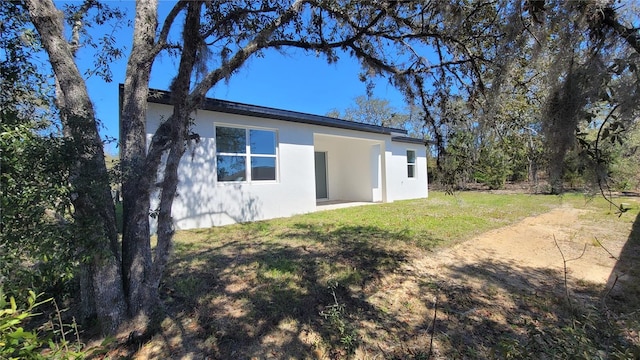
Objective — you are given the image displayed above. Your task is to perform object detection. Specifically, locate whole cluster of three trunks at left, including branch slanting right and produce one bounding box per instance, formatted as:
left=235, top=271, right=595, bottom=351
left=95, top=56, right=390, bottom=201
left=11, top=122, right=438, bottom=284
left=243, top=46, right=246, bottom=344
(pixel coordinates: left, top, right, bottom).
left=28, top=0, right=303, bottom=328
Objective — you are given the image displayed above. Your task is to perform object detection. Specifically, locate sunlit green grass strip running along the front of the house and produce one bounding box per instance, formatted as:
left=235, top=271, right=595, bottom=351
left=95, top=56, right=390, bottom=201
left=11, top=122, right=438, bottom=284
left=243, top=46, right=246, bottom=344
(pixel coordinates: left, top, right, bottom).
left=176, top=192, right=606, bottom=249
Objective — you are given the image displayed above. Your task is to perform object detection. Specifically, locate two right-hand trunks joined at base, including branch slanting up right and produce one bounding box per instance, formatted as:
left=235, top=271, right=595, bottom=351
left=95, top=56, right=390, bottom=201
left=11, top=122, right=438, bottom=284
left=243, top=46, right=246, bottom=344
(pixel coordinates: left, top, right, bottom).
left=121, top=0, right=302, bottom=315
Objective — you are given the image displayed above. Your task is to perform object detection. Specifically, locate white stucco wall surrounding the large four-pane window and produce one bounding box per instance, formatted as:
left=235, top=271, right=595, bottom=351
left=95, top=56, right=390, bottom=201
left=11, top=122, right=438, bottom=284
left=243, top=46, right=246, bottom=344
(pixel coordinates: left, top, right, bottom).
left=147, top=104, right=316, bottom=229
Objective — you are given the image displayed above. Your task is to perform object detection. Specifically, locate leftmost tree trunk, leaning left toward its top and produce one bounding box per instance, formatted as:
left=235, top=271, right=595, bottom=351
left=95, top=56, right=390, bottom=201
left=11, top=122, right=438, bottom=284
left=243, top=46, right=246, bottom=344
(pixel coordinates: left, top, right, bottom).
left=24, top=0, right=126, bottom=333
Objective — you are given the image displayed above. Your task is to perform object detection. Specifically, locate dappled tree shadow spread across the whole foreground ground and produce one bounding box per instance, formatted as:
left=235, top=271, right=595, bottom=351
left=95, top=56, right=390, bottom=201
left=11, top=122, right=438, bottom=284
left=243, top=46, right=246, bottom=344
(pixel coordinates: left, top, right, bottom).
left=138, top=221, right=638, bottom=359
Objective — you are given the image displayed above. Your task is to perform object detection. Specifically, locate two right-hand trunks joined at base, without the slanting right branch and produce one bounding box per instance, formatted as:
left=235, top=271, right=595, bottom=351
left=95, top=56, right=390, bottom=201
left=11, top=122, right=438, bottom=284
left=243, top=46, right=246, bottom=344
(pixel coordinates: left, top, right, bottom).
left=120, top=0, right=201, bottom=316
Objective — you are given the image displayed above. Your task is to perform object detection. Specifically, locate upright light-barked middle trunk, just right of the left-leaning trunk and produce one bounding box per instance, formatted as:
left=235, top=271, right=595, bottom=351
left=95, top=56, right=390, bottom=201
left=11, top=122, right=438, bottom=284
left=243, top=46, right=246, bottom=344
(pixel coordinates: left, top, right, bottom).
left=120, top=0, right=160, bottom=316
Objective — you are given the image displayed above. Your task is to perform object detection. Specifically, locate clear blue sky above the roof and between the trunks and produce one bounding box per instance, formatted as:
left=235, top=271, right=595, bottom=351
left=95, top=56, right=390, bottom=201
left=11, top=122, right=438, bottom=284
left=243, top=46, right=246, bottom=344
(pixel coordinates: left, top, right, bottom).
left=78, top=1, right=405, bottom=153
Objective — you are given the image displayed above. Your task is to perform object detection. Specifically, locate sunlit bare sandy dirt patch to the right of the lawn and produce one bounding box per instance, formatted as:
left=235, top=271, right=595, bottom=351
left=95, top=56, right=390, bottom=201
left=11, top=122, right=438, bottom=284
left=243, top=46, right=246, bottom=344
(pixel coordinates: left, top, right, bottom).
left=428, top=207, right=625, bottom=284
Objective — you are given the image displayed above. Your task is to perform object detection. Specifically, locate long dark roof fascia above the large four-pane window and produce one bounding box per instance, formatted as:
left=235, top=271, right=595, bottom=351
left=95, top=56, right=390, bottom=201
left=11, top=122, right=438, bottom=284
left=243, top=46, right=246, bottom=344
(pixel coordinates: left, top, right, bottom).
left=148, top=89, right=407, bottom=135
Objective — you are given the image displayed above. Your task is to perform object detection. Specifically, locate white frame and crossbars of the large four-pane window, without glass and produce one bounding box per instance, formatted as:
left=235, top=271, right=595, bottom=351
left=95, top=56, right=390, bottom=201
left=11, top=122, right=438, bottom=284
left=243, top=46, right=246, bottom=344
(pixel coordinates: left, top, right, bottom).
left=213, top=123, right=280, bottom=185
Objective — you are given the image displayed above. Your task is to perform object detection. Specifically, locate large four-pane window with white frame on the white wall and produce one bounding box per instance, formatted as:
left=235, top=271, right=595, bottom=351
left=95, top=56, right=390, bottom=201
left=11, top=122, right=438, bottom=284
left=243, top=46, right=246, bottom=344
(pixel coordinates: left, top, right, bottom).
left=216, top=126, right=277, bottom=182
